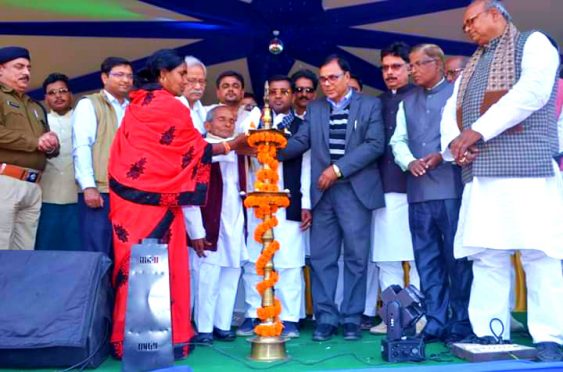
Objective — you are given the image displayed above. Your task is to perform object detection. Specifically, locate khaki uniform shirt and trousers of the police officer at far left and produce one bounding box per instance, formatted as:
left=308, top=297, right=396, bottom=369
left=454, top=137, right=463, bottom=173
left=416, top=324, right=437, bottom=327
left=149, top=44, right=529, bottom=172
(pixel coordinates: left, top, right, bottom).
left=0, top=84, right=49, bottom=249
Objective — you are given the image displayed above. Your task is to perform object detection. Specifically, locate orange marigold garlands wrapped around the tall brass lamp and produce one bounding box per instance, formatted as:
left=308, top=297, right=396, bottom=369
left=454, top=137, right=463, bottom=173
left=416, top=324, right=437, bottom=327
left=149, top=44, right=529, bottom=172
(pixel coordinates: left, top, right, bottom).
left=248, top=131, right=289, bottom=337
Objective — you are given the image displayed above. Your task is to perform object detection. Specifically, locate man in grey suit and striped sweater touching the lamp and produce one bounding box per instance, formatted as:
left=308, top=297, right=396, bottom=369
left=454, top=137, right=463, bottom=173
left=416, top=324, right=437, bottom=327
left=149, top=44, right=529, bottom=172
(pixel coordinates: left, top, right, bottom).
left=279, top=55, right=385, bottom=341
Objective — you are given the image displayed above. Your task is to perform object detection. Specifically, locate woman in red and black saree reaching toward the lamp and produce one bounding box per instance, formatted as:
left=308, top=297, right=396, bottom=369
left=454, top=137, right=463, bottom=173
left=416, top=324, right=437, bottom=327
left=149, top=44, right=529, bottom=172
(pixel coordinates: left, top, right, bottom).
left=109, top=49, right=245, bottom=358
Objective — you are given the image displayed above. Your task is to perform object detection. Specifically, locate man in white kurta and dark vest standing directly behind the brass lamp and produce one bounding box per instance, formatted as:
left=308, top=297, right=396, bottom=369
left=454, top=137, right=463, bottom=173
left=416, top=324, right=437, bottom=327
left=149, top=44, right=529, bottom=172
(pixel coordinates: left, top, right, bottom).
left=238, top=77, right=311, bottom=337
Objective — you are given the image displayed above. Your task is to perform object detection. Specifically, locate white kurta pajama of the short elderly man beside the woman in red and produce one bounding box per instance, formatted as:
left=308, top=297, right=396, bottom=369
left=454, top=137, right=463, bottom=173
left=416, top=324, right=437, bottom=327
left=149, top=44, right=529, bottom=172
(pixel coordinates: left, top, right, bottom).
left=183, top=139, right=248, bottom=333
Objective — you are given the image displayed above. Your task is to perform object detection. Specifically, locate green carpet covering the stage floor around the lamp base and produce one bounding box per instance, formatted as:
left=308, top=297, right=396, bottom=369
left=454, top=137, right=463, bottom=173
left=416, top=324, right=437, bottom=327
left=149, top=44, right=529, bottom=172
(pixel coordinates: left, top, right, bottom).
left=2, top=313, right=532, bottom=372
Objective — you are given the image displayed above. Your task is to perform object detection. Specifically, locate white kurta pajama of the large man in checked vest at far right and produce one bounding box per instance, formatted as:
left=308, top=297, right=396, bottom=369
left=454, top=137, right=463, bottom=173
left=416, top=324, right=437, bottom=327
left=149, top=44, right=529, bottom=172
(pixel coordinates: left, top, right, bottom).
left=442, top=32, right=563, bottom=344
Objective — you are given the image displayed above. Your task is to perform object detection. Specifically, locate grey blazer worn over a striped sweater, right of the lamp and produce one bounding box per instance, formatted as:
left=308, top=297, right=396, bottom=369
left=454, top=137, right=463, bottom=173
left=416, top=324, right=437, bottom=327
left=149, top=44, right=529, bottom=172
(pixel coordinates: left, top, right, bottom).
left=278, top=92, right=385, bottom=209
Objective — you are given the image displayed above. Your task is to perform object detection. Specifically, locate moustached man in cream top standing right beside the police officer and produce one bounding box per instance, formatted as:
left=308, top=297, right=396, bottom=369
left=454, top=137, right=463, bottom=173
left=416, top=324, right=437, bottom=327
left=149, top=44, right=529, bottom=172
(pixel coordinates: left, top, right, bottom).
left=35, top=73, right=80, bottom=251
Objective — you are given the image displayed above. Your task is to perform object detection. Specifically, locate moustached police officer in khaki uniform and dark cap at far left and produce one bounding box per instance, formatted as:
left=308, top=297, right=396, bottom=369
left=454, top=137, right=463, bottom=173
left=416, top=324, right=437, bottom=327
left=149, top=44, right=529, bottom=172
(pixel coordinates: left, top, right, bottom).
left=0, top=46, right=59, bottom=250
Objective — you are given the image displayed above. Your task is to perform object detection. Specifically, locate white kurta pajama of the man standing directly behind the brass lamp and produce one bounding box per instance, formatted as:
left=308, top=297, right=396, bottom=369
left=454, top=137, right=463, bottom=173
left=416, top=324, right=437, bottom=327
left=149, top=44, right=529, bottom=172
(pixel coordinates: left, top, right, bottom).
left=243, top=114, right=311, bottom=322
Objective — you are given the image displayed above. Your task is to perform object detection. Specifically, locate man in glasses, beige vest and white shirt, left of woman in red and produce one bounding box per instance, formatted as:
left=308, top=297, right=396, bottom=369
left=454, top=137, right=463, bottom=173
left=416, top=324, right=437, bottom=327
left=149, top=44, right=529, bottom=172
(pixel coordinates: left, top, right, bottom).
left=72, top=57, right=133, bottom=257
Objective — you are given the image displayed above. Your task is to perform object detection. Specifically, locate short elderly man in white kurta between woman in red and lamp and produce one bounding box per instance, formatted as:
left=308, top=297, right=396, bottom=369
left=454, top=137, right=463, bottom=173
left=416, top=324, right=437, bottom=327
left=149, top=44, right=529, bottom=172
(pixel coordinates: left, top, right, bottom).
left=184, top=106, right=248, bottom=343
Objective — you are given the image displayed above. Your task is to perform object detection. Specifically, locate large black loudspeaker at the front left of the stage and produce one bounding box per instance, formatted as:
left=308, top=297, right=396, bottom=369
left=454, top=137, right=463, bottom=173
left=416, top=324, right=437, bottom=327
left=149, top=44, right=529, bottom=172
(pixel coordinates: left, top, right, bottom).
left=0, top=251, right=113, bottom=368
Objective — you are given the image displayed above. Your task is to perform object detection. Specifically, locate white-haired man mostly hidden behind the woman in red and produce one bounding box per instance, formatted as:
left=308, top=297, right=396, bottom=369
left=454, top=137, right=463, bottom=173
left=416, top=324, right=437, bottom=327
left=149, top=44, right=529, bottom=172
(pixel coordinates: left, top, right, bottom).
left=178, top=56, right=207, bottom=134
